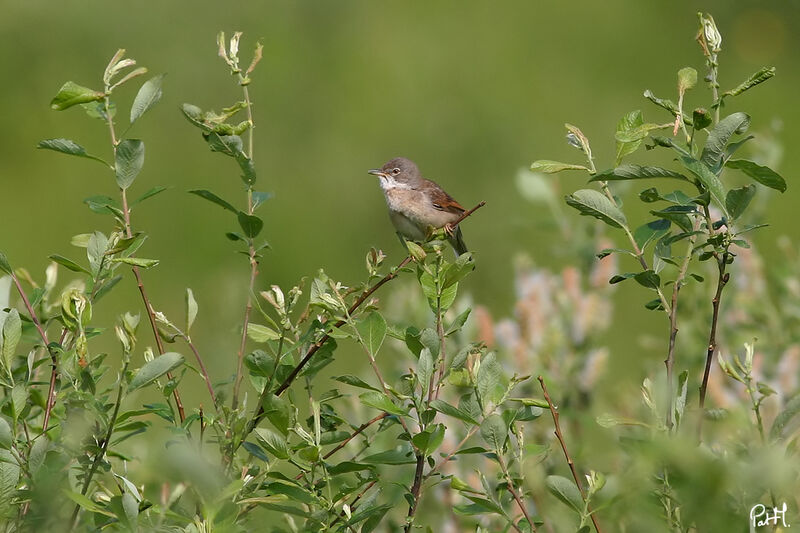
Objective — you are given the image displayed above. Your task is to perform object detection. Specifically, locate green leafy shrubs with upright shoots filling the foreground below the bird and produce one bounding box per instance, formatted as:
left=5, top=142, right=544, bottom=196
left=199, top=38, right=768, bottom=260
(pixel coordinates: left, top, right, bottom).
left=0, top=15, right=800, bottom=533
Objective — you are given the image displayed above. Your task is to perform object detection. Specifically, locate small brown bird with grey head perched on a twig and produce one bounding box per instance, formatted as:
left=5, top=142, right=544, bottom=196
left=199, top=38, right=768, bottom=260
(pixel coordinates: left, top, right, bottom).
left=368, top=157, right=467, bottom=256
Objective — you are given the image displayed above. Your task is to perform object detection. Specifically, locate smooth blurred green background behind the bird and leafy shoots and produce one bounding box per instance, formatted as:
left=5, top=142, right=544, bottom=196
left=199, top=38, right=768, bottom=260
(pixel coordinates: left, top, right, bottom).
left=0, top=0, right=800, bottom=404
